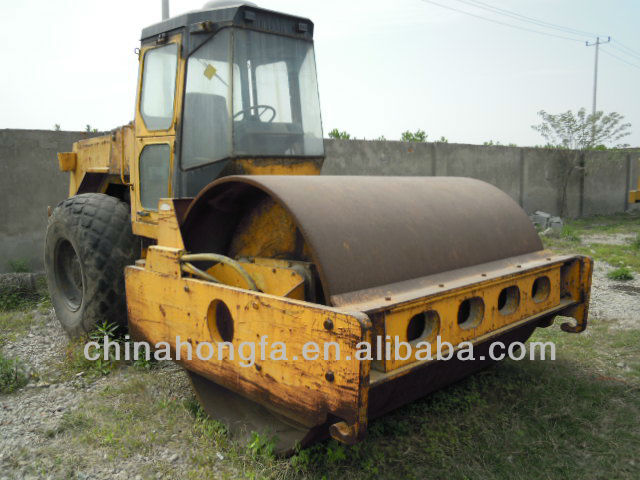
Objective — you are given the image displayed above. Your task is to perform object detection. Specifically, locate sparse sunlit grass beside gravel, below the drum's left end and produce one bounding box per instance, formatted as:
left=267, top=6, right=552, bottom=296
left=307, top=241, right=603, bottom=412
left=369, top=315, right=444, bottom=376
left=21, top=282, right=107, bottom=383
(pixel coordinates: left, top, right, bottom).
left=31, top=366, right=238, bottom=478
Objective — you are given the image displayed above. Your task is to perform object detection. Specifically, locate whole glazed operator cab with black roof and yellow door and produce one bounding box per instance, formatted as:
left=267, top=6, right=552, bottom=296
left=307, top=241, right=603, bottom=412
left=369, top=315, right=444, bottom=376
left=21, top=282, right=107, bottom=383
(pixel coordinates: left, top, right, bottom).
left=134, top=1, right=324, bottom=217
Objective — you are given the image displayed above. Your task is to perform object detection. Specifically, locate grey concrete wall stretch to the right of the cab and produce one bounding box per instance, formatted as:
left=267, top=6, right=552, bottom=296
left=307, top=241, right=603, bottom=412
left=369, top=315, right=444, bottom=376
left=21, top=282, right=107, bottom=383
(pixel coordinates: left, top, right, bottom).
left=322, top=140, right=640, bottom=217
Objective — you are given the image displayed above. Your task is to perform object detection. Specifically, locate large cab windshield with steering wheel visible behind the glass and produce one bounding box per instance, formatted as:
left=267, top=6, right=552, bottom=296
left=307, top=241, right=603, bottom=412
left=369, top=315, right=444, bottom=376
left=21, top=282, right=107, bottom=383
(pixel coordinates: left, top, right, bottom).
left=181, top=28, right=324, bottom=169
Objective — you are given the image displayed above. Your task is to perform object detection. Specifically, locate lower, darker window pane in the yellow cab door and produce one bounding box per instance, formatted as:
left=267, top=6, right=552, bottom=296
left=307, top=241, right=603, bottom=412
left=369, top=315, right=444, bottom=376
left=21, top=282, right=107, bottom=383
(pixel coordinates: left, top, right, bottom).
left=140, top=143, right=171, bottom=210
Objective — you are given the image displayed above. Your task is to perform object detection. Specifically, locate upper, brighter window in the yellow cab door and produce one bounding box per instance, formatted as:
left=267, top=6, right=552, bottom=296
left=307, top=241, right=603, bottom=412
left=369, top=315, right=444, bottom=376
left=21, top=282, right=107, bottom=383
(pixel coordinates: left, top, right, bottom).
left=140, top=43, right=178, bottom=130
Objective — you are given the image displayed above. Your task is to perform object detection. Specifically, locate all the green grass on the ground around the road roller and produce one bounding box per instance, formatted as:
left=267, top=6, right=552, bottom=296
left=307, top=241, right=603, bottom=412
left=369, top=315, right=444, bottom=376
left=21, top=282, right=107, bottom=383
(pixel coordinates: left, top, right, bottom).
left=0, top=216, right=640, bottom=480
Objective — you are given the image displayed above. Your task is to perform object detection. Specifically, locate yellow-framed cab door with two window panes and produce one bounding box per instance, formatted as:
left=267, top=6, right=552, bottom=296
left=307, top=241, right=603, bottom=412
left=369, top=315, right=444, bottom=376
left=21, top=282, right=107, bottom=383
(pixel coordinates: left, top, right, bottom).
left=130, top=35, right=184, bottom=238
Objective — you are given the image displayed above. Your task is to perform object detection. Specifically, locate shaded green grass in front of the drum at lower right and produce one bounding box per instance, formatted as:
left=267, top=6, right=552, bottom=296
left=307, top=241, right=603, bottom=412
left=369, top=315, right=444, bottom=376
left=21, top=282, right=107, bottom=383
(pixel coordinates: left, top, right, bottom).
left=276, top=323, right=640, bottom=479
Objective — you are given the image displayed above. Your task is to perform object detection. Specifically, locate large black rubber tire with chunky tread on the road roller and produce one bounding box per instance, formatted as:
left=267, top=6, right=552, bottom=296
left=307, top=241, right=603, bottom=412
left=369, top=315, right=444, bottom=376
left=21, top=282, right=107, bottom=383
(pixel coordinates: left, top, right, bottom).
left=44, top=193, right=139, bottom=337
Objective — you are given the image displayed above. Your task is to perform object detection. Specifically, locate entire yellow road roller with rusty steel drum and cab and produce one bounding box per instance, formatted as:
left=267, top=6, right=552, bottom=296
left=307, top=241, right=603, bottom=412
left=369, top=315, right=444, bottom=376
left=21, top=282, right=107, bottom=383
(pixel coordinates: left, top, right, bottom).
left=45, top=2, right=592, bottom=454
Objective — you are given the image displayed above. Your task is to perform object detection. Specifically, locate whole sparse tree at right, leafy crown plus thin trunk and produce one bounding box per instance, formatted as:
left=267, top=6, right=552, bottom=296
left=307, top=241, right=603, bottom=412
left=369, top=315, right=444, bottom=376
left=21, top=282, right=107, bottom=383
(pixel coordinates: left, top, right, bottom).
left=531, top=108, right=631, bottom=216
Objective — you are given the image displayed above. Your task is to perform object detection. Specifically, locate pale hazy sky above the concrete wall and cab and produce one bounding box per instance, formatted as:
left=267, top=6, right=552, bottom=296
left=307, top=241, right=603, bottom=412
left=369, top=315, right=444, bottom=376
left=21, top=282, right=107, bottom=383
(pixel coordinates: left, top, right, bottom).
left=0, top=0, right=640, bottom=146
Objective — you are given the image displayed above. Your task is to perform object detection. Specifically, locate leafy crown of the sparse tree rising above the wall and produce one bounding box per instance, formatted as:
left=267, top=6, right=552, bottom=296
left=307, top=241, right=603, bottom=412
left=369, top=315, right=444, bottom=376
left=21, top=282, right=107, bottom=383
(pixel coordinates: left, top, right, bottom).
left=531, top=108, right=631, bottom=150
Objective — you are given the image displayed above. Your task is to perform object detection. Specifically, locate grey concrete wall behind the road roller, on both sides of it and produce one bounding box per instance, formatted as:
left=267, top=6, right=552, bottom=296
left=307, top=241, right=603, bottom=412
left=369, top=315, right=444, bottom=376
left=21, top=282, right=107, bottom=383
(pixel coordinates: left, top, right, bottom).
left=0, top=130, right=640, bottom=272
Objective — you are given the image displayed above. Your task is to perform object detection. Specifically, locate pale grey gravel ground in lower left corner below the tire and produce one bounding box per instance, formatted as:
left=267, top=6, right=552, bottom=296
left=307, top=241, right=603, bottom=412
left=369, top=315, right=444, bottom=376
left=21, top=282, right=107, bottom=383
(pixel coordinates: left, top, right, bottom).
left=0, top=310, right=189, bottom=480
